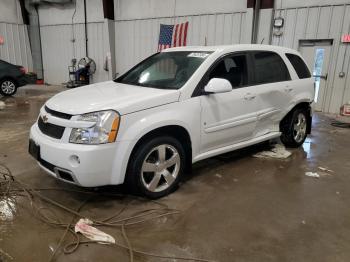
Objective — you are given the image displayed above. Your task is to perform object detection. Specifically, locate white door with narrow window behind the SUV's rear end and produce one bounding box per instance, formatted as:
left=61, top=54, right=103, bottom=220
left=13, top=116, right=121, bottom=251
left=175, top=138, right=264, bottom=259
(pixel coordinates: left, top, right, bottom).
left=299, top=39, right=333, bottom=111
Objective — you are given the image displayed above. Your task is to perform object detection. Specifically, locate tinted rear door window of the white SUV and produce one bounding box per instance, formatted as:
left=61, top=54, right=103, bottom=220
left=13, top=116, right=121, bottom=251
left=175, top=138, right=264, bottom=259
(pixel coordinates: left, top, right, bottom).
left=253, top=52, right=290, bottom=84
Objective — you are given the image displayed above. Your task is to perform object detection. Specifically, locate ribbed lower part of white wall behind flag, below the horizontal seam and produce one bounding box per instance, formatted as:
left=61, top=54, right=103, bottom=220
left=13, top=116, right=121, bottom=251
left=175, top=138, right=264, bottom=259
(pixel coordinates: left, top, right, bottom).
left=115, top=12, right=251, bottom=74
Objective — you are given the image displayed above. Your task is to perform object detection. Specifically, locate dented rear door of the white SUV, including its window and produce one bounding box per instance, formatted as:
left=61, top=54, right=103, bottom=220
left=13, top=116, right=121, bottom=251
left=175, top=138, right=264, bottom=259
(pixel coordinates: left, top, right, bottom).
left=251, top=51, right=295, bottom=137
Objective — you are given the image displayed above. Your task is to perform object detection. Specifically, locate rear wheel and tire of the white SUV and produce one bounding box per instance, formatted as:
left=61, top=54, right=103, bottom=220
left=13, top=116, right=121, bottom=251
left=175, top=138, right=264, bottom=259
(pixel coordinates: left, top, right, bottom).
left=281, top=108, right=309, bottom=148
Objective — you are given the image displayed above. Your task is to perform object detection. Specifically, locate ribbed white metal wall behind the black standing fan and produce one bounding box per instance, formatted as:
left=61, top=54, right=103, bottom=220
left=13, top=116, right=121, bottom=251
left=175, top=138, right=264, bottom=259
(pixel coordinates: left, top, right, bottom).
left=40, top=22, right=109, bottom=84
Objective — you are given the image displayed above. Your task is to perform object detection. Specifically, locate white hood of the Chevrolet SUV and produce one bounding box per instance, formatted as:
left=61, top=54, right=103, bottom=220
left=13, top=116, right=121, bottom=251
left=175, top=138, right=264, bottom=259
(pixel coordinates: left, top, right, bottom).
left=46, top=81, right=180, bottom=115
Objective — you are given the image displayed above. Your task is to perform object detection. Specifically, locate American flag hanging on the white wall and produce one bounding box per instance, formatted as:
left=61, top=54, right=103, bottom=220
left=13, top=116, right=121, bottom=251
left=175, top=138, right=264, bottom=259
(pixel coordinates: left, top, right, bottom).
left=158, top=22, right=188, bottom=52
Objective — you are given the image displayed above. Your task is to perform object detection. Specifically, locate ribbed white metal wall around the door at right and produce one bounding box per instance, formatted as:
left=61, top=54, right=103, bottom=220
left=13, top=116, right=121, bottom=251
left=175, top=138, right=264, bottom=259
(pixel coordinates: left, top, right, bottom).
left=272, top=4, right=350, bottom=113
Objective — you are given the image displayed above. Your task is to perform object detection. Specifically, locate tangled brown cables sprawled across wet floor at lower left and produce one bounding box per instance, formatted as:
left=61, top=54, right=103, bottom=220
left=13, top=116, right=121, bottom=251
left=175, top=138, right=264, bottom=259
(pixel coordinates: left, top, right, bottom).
left=0, top=164, right=213, bottom=262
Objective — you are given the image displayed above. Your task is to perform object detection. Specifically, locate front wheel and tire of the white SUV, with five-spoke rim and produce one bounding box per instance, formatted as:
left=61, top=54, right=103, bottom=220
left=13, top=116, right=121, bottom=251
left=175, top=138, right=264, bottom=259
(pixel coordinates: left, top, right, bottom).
left=126, top=136, right=186, bottom=199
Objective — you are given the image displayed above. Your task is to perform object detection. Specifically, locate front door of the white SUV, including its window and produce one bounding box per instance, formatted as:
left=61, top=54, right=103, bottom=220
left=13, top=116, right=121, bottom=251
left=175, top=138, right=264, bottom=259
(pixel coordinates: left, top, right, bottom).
left=200, top=53, right=257, bottom=152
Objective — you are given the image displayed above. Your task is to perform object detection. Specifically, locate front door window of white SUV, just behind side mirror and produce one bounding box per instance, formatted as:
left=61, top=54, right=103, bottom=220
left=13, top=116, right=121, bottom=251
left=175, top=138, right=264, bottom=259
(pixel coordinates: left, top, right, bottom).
left=209, top=55, right=248, bottom=88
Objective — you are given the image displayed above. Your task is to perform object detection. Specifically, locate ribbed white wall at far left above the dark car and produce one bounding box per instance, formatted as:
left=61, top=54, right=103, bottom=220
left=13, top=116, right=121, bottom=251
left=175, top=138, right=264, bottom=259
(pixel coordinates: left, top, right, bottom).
left=0, top=22, right=33, bottom=71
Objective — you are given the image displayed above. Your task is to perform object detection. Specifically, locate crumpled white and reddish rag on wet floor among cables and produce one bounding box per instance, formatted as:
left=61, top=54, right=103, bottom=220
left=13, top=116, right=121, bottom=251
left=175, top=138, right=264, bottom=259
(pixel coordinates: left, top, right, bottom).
left=74, top=218, right=115, bottom=244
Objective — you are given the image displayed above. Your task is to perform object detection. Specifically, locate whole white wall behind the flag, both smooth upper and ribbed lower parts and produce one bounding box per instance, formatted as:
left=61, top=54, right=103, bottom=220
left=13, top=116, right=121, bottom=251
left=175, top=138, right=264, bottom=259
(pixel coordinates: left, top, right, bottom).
left=114, top=0, right=253, bottom=74
